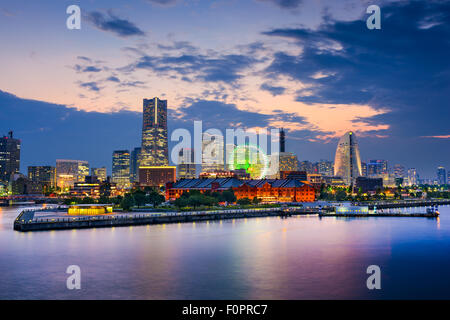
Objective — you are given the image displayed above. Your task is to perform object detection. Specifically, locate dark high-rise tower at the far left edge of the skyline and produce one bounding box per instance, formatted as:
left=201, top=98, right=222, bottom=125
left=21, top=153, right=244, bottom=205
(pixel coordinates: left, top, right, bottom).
left=0, top=131, right=20, bottom=184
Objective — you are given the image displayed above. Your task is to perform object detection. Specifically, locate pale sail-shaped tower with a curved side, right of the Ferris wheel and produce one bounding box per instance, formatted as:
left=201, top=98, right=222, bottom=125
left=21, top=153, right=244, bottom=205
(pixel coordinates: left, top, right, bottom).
left=334, top=131, right=362, bottom=185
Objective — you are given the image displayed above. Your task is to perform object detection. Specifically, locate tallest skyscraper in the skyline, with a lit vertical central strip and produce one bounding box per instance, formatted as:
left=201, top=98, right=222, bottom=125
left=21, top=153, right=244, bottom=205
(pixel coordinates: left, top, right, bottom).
left=139, top=97, right=169, bottom=166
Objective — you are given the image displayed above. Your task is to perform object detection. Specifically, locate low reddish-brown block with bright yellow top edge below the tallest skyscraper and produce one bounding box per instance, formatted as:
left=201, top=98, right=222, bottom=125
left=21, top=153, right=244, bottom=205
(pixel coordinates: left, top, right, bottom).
left=139, top=166, right=177, bottom=188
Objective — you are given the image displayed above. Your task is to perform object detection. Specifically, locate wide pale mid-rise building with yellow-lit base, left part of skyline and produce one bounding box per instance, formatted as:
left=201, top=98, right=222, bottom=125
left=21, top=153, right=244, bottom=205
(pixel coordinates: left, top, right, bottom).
left=56, top=159, right=89, bottom=189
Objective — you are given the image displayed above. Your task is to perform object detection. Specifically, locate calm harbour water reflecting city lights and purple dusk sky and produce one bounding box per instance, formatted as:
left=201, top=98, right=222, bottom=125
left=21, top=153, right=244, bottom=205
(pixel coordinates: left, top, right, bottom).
left=0, top=207, right=450, bottom=299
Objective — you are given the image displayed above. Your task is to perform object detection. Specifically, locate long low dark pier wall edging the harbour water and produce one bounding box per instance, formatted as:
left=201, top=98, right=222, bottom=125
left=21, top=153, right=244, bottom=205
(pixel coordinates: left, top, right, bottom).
left=14, top=207, right=319, bottom=232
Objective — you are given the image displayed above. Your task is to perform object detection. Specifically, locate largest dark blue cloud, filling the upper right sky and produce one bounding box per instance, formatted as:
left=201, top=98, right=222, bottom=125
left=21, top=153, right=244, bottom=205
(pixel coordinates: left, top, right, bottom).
left=264, top=1, right=450, bottom=138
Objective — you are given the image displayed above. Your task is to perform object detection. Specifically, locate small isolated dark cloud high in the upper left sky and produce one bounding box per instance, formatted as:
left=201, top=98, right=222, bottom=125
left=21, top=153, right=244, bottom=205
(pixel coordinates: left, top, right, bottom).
left=87, top=11, right=145, bottom=37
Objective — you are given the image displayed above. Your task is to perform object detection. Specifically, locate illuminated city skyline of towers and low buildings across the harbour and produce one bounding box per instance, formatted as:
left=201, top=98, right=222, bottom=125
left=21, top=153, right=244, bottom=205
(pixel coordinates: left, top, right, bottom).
left=0, top=97, right=450, bottom=201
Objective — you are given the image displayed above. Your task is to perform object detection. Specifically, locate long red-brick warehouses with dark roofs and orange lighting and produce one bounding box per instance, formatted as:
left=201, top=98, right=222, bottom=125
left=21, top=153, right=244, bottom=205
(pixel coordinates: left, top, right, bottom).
left=166, top=178, right=315, bottom=202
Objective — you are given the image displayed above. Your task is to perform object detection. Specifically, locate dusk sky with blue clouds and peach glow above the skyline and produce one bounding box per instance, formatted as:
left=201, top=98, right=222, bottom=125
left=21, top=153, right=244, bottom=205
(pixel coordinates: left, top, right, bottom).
left=0, top=0, right=450, bottom=177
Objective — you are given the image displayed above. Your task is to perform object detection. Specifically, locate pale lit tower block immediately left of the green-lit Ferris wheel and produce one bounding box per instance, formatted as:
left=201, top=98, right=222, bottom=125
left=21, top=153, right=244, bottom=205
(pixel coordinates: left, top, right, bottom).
left=202, top=132, right=225, bottom=172
